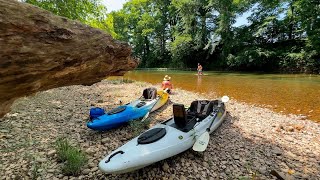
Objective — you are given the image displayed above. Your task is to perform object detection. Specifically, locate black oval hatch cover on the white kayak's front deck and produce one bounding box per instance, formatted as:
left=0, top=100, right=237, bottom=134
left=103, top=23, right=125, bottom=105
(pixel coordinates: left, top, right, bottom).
left=138, top=128, right=167, bottom=144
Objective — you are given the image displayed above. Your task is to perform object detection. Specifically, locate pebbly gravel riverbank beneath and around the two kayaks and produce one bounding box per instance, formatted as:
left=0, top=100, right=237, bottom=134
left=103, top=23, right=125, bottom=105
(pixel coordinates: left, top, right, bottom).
left=0, top=80, right=320, bottom=179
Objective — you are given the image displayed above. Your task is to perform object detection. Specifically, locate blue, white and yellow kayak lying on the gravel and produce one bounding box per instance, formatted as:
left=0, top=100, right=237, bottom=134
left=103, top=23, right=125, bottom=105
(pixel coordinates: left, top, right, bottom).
left=87, top=88, right=169, bottom=131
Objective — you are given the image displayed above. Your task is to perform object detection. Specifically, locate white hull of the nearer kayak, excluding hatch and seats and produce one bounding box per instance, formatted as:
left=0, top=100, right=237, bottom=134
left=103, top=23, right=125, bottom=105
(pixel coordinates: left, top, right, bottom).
left=99, top=100, right=226, bottom=174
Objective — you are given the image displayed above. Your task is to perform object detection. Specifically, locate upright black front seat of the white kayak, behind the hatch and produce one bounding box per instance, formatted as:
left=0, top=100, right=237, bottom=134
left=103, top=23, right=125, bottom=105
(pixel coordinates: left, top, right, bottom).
left=173, top=104, right=197, bottom=132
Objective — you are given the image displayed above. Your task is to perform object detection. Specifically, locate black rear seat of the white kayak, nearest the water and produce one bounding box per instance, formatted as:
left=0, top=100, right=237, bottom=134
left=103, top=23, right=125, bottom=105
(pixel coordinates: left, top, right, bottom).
left=187, top=100, right=215, bottom=121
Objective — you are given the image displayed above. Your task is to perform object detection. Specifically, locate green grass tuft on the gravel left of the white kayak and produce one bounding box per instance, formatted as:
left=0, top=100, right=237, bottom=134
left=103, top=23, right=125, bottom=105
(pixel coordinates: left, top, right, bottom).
left=56, top=138, right=87, bottom=175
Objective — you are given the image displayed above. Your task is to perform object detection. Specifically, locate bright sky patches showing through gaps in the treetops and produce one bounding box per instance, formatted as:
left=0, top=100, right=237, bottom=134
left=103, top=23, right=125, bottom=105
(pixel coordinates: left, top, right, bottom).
left=102, top=0, right=252, bottom=27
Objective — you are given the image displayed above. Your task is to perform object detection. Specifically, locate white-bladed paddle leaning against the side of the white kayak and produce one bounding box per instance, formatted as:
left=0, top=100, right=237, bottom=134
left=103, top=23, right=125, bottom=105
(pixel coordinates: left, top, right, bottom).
left=192, top=96, right=229, bottom=152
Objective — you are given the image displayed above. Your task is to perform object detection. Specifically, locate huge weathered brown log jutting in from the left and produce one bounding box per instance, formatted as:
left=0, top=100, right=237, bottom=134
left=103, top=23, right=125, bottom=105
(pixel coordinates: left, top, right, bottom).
left=0, top=0, right=138, bottom=117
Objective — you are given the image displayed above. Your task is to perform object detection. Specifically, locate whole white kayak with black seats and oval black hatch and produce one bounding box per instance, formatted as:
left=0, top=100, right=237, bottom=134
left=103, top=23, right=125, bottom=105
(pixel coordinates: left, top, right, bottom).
left=99, top=100, right=226, bottom=174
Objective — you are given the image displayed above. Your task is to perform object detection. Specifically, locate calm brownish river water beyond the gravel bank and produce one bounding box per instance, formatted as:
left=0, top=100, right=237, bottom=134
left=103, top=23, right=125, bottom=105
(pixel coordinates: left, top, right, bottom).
left=117, top=70, right=320, bottom=122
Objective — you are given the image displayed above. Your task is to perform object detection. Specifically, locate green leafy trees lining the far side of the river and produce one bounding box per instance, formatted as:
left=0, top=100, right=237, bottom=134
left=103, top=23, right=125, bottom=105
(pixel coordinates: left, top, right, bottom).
left=25, top=0, right=320, bottom=73
